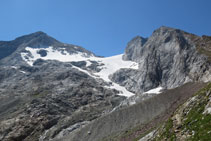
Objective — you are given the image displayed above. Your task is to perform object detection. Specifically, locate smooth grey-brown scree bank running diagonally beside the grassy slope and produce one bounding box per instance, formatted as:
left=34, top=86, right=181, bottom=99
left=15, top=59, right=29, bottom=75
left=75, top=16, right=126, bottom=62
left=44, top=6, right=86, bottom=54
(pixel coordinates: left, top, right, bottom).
left=59, top=83, right=204, bottom=141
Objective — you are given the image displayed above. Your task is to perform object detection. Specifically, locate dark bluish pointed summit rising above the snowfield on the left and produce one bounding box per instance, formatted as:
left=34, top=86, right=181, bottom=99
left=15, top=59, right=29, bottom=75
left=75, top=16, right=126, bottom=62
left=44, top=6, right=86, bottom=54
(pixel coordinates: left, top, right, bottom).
left=0, top=32, right=94, bottom=65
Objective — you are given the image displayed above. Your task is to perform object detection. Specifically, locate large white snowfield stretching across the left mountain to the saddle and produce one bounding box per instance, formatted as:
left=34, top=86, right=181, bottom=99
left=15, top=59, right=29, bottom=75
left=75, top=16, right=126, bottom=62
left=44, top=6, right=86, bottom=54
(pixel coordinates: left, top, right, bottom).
left=21, top=46, right=138, bottom=97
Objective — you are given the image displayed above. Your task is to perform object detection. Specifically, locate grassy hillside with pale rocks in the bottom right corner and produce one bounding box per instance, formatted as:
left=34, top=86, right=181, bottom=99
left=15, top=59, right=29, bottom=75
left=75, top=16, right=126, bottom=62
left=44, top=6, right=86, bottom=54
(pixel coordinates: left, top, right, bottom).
left=151, top=84, right=211, bottom=141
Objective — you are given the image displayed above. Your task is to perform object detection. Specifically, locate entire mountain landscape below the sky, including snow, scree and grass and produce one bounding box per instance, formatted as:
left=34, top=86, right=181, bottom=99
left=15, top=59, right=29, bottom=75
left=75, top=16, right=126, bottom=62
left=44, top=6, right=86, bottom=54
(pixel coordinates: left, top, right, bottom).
left=0, top=26, right=211, bottom=141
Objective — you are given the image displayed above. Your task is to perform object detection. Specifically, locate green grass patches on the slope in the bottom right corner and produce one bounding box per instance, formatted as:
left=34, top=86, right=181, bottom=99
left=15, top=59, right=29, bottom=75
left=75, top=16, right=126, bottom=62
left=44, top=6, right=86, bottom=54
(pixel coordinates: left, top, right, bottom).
left=155, top=83, right=211, bottom=141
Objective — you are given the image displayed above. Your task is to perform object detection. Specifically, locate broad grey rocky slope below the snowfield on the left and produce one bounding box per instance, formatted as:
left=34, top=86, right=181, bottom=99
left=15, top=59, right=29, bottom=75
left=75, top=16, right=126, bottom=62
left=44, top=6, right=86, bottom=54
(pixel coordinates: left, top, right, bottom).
left=0, top=61, right=125, bottom=141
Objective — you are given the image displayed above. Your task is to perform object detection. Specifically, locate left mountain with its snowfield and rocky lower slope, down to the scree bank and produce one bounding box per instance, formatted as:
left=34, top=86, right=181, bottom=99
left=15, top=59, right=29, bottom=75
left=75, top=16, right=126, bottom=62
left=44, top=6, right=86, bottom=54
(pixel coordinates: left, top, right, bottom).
left=0, top=32, right=137, bottom=140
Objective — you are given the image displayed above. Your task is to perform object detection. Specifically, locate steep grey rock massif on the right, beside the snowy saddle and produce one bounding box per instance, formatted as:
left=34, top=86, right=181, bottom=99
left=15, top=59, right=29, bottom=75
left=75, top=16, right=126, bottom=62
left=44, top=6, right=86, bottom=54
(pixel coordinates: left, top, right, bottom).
left=111, top=27, right=211, bottom=93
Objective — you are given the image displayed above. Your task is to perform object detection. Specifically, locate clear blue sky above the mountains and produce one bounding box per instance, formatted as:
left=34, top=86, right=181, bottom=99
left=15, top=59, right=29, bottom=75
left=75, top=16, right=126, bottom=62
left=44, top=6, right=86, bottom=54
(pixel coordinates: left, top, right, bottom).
left=0, top=0, right=211, bottom=56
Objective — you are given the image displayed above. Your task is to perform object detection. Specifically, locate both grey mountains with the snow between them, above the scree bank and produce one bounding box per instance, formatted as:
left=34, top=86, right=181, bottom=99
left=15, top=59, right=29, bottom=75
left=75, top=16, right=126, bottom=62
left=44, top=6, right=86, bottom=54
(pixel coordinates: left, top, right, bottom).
left=0, top=27, right=211, bottom=141
